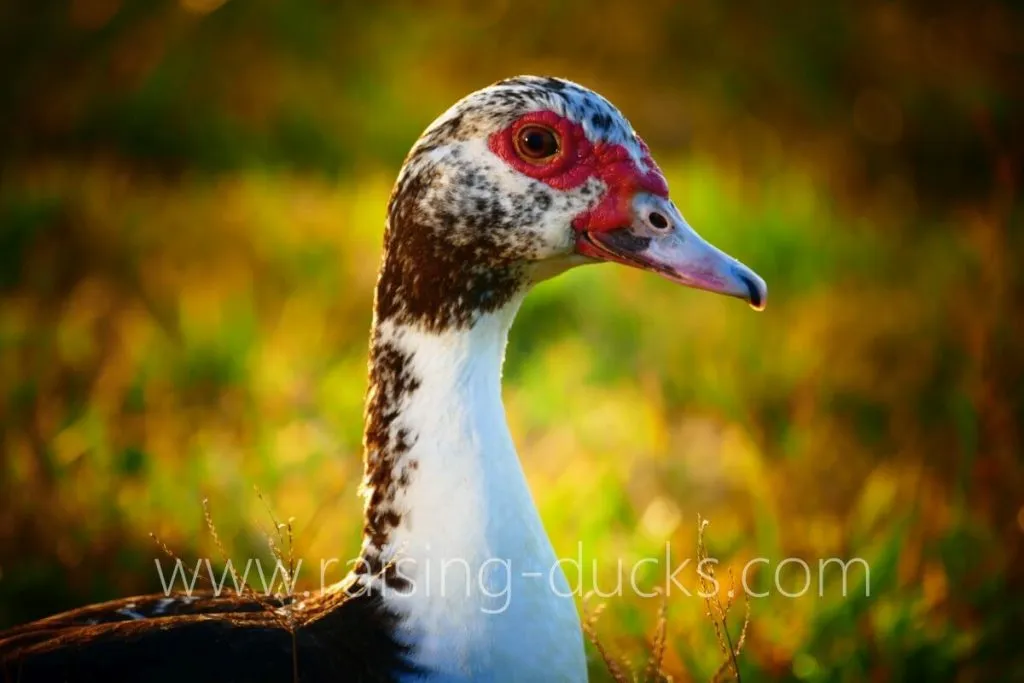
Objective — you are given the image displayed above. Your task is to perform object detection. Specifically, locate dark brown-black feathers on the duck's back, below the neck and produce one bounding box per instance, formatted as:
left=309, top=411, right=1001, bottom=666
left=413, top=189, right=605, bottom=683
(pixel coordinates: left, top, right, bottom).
left=0, top=593, right=412, bottom=683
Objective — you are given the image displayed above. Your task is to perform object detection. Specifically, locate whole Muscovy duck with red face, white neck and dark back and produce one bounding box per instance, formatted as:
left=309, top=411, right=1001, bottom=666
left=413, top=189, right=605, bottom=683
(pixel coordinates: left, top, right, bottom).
left=0, top=77, right=766, bottom=683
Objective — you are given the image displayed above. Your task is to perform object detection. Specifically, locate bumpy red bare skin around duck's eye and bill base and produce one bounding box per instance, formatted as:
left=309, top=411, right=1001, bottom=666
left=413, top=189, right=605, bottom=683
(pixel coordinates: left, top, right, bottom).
left=487, top=112, right=669, bottom=232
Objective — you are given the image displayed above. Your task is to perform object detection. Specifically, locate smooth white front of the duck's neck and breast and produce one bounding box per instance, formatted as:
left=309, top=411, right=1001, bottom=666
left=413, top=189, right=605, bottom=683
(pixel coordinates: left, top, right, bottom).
left=360, top=305, right=587, bottom=681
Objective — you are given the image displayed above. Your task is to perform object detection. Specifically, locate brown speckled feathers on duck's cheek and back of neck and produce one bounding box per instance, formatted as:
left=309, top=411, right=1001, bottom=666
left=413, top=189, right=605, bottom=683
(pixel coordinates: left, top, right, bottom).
left=357, top=125, right=552, bottom=583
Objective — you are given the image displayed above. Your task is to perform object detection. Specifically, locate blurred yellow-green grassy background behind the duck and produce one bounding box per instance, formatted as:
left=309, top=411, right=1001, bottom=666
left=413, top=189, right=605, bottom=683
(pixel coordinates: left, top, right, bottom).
left=0, top=0, right=1024, bottom=681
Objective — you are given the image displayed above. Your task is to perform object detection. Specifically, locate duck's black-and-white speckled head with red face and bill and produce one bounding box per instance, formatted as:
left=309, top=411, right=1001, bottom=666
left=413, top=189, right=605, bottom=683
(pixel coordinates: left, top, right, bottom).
left=377, top=76, right=767, bottom=330
